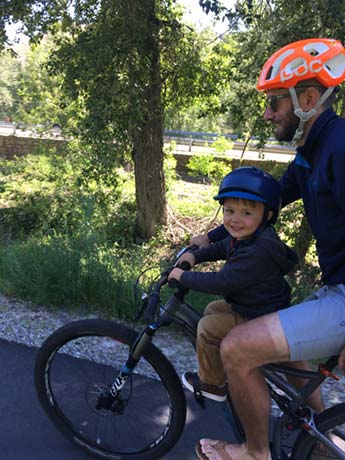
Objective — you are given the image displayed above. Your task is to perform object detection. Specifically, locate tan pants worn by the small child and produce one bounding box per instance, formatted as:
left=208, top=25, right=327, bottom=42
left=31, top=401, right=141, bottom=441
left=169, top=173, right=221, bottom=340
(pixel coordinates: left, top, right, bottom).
left=197, top=300, right=247, bottom=385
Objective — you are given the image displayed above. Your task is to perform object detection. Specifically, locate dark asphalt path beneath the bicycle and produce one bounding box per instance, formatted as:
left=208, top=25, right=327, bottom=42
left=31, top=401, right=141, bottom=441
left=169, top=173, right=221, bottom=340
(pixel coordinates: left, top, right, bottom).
left=0, top=339, right=234, bottom=460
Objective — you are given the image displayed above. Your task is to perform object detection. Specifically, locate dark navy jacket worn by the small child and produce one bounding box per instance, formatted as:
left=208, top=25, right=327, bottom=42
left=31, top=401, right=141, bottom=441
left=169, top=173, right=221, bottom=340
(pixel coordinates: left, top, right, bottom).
left=180, top=226, right=297, bottom=318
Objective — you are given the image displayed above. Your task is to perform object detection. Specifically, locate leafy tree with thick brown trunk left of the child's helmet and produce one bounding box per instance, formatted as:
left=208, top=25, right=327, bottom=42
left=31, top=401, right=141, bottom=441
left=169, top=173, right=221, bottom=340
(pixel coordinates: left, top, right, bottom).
left=0, top=0, right=226, bottom=237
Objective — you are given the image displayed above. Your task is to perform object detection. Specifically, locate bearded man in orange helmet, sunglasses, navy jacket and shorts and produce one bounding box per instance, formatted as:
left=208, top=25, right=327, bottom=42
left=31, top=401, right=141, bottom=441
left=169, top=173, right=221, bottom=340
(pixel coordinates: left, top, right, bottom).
left=194, top=39, right=345, bottom=460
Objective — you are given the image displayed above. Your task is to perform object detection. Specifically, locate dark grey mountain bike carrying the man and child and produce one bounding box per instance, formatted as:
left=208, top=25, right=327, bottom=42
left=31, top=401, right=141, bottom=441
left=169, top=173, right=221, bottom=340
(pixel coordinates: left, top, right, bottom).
left=35, top=248, right=345, bottom=460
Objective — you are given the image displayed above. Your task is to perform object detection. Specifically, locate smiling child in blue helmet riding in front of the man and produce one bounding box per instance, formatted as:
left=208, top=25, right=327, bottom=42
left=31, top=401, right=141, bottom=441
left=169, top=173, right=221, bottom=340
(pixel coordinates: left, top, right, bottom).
left=169, top=167, right=297, bottom=401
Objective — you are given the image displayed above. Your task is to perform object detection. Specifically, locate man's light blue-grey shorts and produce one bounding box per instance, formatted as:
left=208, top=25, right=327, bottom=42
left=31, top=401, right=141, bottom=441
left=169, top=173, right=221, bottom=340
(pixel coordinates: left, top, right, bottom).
left=278, top=284, right=345, bottom=361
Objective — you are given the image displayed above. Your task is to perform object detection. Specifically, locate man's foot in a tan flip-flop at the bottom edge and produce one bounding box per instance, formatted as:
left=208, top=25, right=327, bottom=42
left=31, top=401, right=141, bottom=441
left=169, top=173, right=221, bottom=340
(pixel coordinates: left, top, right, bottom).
left=196, top=439, right=271, bottom=460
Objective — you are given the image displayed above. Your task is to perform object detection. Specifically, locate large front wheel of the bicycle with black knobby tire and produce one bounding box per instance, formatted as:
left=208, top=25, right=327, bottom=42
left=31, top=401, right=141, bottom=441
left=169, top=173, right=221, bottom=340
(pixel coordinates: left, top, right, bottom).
left=34, top=319, right=186, bottom=460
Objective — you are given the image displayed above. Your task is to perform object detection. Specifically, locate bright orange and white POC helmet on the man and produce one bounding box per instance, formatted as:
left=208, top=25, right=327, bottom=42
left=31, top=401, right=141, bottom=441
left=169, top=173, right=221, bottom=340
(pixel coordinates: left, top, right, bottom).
left=257, top=38, right=345, bottom=91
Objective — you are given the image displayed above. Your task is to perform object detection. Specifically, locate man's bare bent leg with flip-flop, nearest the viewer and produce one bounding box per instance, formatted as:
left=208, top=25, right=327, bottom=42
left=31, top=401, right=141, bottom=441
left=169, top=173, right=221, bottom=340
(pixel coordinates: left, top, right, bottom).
left=201, top=313, right=289, bottom=460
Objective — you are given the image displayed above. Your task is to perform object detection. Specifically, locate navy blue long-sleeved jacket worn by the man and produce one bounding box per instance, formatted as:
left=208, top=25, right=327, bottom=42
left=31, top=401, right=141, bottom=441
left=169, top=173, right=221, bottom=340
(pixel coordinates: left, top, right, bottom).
left=209, top=109, right=345, bottom=284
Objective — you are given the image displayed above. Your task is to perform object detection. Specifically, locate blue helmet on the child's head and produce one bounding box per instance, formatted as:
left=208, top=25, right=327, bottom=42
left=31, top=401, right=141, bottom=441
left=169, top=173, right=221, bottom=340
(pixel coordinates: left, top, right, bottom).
left=214, top=166, right=281, bottom=223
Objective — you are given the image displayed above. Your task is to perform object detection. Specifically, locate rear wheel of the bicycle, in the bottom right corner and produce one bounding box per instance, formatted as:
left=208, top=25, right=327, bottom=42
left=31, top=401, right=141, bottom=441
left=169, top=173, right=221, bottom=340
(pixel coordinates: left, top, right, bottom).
left=291, top=403, right=345, bottom=460
